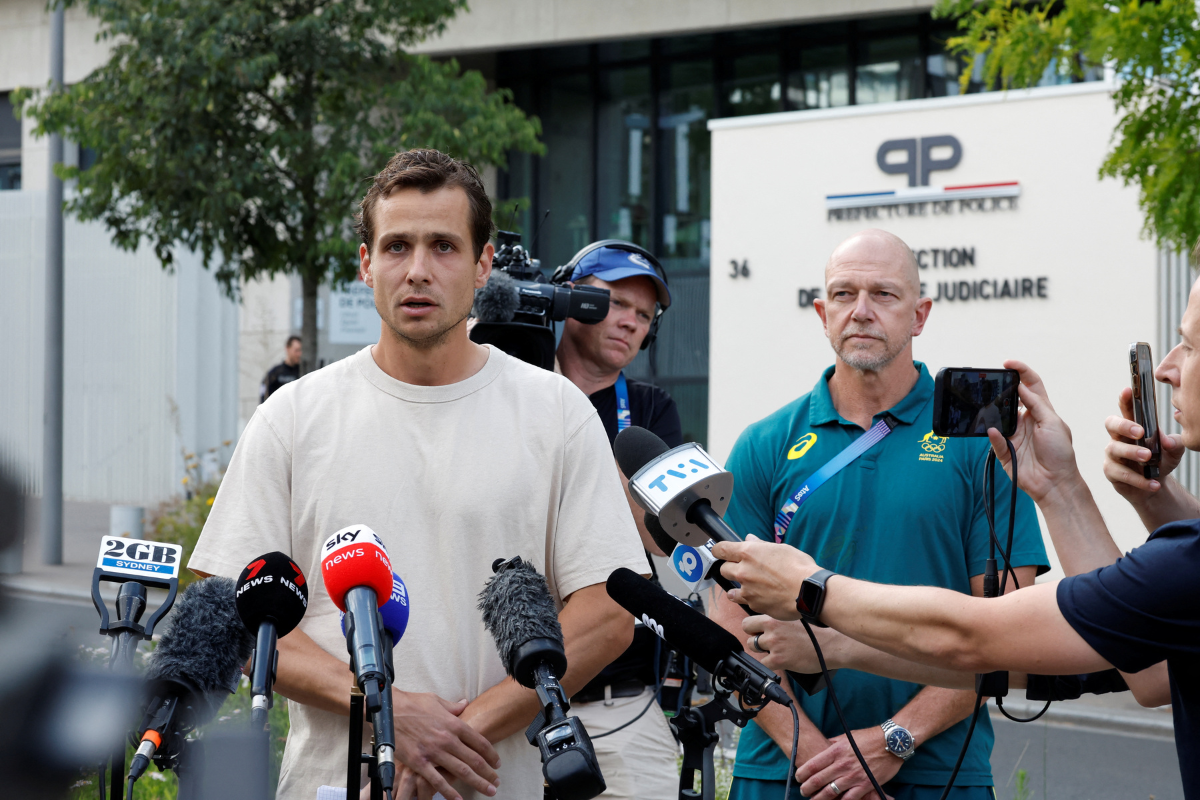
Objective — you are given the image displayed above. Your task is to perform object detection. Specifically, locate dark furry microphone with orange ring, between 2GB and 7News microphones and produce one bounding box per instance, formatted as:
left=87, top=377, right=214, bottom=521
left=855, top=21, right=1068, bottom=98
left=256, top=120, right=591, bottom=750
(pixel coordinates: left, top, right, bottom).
left=128, top=577, right=254, bottom=783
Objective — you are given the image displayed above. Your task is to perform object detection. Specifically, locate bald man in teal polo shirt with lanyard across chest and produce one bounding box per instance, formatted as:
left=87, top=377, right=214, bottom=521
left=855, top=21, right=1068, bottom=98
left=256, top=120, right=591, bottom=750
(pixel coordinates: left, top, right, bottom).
left=713, top=230, right=1049, bottom=800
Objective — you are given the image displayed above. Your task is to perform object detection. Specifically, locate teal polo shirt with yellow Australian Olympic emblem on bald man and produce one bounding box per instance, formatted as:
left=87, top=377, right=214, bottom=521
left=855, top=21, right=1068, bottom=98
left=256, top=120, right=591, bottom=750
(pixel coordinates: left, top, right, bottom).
left=726, top=362, right=1049, bottom=786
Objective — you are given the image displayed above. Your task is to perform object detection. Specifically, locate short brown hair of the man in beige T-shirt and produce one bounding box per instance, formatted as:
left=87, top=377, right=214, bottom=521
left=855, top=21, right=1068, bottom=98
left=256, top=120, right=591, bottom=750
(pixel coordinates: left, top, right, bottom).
left=354, top=150, right=492, bottom=260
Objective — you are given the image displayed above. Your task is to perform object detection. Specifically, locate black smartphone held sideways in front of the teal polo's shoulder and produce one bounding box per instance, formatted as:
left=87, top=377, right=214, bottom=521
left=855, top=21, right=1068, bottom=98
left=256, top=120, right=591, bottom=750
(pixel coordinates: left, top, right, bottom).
left=934, top=367, right=1021, bottom=437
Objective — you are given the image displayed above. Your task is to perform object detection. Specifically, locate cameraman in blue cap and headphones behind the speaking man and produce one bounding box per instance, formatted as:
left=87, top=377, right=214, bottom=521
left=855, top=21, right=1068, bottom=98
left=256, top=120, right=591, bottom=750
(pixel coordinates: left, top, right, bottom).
left=556, top=240, right=683, bottom=800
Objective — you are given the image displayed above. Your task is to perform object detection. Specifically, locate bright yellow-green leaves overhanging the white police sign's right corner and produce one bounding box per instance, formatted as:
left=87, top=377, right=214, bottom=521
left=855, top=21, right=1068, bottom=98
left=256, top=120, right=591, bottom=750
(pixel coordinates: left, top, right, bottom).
left=934, top=0, right=1200, bottom=249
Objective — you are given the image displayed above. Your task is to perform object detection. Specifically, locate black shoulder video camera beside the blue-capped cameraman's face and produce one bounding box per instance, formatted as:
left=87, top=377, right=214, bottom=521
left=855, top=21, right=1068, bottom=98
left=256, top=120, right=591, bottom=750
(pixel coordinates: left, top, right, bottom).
left=470, top=230, right=608, bottom=369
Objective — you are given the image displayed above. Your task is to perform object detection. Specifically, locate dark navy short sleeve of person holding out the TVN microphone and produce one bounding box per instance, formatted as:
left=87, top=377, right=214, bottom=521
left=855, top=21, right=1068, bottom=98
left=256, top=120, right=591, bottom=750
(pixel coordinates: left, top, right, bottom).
left=1057, top=519, right=1200, bottom=672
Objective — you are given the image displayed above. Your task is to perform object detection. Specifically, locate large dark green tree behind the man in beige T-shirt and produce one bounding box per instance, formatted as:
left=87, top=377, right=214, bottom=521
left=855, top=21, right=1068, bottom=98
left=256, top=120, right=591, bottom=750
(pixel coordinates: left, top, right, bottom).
left=14, top=0, right=541, bottom=363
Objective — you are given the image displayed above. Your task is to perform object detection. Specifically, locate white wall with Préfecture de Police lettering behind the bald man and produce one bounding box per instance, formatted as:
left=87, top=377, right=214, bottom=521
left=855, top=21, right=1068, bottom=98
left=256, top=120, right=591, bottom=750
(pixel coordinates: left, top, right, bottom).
left=709, top=84, right=1163, bottom=578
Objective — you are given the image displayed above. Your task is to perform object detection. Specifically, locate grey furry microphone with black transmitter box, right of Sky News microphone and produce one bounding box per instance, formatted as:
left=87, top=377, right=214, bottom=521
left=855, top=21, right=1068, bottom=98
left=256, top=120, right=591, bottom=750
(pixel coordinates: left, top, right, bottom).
left=479, top=557, right=607, bottom=800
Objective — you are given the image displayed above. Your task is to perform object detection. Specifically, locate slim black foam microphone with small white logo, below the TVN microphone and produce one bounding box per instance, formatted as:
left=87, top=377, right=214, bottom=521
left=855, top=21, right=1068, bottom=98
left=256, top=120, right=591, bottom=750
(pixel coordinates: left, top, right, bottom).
left=606, top=567, right=792, bottom=705
